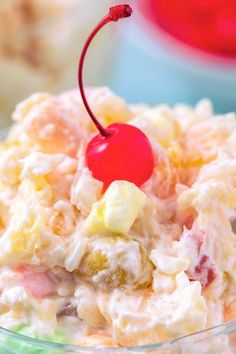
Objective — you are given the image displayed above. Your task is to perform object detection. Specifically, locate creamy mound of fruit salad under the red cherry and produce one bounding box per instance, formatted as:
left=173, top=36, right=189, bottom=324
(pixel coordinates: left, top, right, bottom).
left=0, top=87, right=236, bottom=347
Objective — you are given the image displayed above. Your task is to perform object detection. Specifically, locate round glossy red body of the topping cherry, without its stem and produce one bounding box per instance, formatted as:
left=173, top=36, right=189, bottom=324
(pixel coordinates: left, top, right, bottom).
left=86, top=123, right=154, bottom=189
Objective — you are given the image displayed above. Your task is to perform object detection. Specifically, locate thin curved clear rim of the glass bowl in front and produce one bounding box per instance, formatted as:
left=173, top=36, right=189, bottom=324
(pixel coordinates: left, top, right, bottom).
left=0, top=318, right=236, bottom=353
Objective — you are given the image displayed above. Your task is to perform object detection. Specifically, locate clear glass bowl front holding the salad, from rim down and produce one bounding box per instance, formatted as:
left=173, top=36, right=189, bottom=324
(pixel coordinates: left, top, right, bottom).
left=0, top=320, right=236, bottom=354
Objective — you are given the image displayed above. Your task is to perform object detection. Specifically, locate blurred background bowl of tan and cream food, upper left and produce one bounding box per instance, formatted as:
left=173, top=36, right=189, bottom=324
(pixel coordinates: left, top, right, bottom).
left=0, top=0, right=114, bottom=128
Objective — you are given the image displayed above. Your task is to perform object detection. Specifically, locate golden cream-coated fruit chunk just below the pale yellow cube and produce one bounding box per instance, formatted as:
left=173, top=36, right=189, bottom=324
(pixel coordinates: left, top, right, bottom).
left=78, top=236, right=153, bottom=290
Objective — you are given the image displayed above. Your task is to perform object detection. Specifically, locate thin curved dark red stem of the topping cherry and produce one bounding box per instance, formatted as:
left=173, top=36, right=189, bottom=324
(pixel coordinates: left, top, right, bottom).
left=78, top=5, right=133, bottom=138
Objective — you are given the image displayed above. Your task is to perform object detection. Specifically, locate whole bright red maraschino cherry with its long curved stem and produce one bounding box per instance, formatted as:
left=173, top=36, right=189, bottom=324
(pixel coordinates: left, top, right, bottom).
left=78, top=5, right=154, bottom=189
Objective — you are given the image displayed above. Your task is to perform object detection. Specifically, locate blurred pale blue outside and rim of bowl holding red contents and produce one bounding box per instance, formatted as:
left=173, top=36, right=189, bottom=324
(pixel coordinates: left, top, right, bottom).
left=110, top=2, right=236, bottom=112
